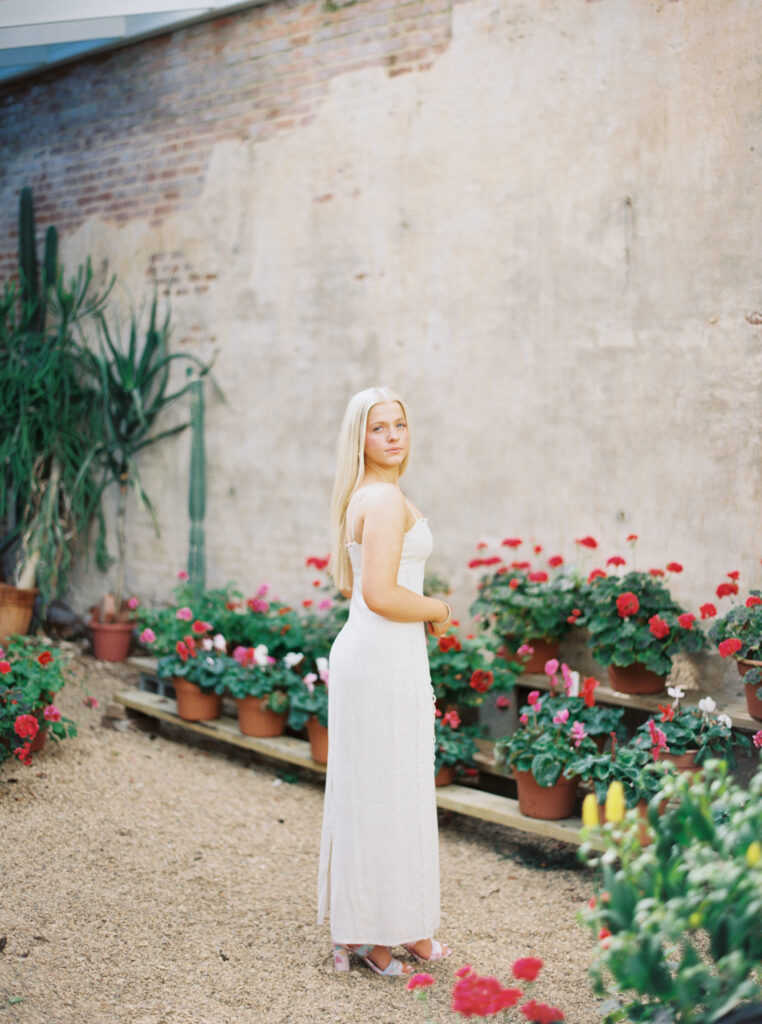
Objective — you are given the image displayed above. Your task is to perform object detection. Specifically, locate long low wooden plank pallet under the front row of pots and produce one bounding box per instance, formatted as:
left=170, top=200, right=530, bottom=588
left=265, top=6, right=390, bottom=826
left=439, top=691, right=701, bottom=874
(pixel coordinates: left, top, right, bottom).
left=114, top=688, right=582, bottom=845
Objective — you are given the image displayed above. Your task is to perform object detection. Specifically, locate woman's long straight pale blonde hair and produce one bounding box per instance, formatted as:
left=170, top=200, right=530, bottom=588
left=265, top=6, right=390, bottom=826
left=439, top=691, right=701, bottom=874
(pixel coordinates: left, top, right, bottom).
left=329, top=387, right=410, bottom=590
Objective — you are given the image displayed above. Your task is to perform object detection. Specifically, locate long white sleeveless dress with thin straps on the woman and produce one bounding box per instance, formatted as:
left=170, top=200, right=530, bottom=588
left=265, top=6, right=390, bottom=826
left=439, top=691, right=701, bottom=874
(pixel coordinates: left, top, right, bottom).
left=318, top=503, right=439, bottom=946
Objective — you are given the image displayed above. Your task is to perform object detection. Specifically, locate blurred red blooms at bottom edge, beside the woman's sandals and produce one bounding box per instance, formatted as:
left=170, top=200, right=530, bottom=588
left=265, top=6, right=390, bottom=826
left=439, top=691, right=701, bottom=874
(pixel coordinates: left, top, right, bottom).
left=407, top=956, right=565, bottom=1024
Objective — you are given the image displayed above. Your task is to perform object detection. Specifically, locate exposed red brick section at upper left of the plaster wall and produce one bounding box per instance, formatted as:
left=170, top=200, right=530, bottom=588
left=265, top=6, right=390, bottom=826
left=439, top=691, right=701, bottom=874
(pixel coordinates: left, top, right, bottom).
left=0, top=0, right=452, bottom=287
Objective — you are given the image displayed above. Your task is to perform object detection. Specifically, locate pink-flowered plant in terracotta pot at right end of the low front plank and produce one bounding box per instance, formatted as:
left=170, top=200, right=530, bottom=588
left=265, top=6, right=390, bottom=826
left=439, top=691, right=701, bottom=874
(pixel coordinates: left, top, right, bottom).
left=495, top=690, right=596, bottom=818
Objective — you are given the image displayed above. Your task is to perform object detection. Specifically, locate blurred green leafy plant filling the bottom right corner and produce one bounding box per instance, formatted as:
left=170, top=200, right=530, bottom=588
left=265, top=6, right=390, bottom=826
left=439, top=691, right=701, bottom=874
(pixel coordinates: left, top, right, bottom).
left=581, top=760, right=762, bottom=1024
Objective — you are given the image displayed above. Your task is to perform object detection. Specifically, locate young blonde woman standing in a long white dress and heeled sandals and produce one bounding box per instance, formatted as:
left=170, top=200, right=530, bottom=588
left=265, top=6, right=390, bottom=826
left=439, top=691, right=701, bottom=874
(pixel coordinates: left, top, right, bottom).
left=318, top=388, right=451, bottom=976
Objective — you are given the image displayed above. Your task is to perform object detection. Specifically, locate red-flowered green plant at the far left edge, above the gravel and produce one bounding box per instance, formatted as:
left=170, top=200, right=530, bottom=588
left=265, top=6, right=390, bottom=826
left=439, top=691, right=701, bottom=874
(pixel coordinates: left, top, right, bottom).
left=0, top=637, right=77, bottom=765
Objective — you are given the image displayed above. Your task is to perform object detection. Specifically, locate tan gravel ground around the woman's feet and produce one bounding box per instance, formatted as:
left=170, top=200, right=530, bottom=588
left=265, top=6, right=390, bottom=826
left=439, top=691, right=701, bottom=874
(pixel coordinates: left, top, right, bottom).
left=0, top=648, right=600, bottom=1024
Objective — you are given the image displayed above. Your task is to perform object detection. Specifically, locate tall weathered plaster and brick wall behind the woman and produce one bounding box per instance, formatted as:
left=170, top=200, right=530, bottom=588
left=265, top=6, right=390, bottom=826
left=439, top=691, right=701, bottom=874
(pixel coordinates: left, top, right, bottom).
left=0, top=0, right=762, bottom=610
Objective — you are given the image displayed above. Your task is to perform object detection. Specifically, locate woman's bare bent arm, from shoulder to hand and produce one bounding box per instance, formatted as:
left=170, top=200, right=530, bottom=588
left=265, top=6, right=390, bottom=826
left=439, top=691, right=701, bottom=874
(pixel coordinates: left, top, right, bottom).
left=363, top=484, right=450, bottom=633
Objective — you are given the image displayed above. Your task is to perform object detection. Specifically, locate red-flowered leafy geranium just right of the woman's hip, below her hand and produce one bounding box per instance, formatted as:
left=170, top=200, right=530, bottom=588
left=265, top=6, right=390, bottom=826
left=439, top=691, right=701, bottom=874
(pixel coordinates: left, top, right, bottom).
left=428, top=630, right=521, bottom=712
